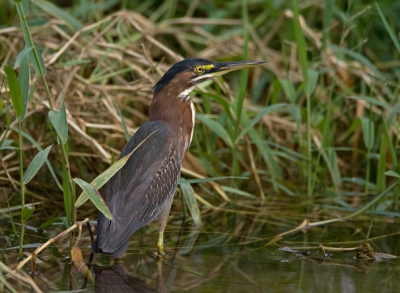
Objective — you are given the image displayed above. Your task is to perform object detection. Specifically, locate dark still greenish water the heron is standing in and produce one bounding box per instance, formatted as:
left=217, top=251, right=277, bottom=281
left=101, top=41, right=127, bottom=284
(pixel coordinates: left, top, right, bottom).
left=2, top=202, right=400, bottom=293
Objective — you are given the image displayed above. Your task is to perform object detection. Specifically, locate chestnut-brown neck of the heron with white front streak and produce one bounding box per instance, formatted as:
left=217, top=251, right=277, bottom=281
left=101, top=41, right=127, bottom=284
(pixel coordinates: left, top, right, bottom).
left=149, top=88, right=195, bottom=159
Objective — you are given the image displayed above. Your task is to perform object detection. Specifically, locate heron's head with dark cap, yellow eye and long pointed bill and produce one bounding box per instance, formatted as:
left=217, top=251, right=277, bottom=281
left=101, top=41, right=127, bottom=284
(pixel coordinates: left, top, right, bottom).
left=153, top=58, right=265, bottom=95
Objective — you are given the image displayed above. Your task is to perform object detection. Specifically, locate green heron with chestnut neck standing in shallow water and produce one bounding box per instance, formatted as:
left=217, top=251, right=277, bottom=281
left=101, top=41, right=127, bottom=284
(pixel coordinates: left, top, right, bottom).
left=93, top=59, right=265, bottom=258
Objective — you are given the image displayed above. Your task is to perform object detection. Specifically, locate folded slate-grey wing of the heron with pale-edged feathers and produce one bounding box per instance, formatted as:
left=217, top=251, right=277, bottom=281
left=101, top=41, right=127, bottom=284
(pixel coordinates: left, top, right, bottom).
left=94, top=121, right=181, bottom=254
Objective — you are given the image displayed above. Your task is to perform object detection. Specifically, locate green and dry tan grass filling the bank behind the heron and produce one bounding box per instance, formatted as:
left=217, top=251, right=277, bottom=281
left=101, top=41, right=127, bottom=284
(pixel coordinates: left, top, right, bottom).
left=0, top=0, right=400, bottom=286
